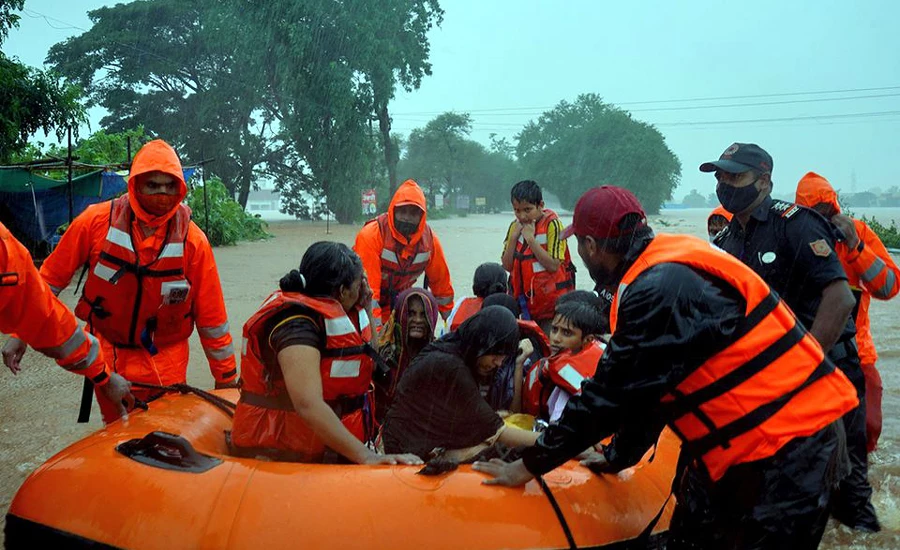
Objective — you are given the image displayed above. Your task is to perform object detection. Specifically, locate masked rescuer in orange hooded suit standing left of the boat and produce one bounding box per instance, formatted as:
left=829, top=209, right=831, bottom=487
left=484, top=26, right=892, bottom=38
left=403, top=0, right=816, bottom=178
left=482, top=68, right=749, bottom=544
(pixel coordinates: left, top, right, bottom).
left=0, top=139, right=237, bottom=423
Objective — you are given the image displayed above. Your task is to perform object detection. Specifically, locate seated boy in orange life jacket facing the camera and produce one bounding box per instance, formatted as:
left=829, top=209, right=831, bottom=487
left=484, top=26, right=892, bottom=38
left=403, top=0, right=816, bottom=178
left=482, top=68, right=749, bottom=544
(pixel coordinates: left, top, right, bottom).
left=523, top=290, right=607, bottom=422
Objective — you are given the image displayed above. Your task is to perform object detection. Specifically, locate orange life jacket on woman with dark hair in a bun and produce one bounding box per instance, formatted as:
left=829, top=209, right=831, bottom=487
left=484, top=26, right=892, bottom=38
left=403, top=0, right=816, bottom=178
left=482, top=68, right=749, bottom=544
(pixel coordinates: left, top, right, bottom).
left=231, top=291, right=375, bottom=461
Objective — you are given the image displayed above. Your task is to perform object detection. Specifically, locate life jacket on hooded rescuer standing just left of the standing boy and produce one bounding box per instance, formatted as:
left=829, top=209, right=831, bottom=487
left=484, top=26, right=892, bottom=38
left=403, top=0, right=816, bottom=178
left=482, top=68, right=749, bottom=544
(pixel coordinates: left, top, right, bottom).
left=367, top=214, right=434, bottom=310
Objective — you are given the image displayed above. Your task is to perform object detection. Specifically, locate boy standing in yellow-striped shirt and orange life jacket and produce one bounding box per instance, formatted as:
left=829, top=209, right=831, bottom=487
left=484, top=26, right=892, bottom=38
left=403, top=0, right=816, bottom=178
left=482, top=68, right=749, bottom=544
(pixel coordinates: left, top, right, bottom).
left=501, top=180, right=575, bottom=334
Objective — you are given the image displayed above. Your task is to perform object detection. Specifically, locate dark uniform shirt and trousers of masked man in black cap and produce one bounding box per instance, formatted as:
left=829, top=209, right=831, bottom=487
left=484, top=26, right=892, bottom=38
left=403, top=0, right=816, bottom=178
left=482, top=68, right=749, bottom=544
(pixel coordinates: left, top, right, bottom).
left=714, top=193, right=878, bottom=529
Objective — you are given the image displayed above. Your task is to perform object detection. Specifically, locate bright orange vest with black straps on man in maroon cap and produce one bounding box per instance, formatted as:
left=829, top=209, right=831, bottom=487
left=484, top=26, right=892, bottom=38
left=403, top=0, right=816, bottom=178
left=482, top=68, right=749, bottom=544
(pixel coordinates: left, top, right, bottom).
left=610, top=235, right=858, bottom=480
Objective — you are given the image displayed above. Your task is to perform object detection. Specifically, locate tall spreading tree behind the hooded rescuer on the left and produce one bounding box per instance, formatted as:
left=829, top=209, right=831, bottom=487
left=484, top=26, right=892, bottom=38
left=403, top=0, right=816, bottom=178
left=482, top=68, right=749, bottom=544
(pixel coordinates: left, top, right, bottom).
left=47, top=0, right=281, bottom=206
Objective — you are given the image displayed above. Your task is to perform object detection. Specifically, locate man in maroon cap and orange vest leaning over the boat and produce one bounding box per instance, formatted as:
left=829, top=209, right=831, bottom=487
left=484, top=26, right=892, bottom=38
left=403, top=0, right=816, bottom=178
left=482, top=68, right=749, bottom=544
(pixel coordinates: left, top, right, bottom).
left=474, top=186, right=858, bottom=549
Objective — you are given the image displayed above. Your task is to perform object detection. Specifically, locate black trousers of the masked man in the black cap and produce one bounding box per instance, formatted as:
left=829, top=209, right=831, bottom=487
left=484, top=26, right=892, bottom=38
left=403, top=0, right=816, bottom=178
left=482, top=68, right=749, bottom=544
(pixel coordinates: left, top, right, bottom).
left=828, top=341, right=880, bottom=531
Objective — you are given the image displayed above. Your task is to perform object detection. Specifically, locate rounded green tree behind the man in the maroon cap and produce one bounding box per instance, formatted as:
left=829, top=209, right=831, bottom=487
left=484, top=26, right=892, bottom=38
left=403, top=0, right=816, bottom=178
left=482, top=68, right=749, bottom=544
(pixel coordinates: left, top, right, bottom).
left=516, top=94, right=681, bottom=213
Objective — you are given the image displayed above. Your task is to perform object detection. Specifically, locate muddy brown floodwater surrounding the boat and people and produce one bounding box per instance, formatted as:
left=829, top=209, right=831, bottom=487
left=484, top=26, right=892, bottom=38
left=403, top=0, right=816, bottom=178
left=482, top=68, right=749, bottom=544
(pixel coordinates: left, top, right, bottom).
left=0, top=210, right=900, bottom=549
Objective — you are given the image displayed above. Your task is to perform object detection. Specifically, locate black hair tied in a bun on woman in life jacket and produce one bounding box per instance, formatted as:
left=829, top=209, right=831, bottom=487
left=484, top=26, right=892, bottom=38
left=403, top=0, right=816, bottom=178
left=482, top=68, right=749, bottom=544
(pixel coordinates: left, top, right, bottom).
left=279, top=241, right=363, bottom=297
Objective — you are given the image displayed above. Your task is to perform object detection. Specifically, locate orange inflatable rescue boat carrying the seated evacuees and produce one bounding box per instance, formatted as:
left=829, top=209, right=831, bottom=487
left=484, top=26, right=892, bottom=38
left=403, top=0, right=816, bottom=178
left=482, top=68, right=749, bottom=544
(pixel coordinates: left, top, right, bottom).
left=6, top=390, right=679, bottom=550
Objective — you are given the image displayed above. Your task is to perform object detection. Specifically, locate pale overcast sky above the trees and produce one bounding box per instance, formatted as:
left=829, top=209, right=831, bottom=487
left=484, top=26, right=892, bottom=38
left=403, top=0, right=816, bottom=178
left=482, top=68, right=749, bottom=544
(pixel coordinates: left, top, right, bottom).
left=3, top=0, right=900, bottom=198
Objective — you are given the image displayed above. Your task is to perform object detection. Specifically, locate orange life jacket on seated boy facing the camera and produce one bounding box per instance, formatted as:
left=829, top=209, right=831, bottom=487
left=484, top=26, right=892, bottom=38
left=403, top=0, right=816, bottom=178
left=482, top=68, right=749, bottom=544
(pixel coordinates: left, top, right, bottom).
left=522, top=340, right=606, bottom=418
